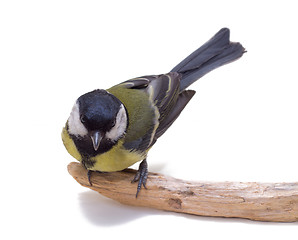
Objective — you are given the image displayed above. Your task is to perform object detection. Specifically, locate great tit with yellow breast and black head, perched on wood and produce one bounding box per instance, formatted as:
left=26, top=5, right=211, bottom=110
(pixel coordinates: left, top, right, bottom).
left=62, top=28, right=245, bottom=197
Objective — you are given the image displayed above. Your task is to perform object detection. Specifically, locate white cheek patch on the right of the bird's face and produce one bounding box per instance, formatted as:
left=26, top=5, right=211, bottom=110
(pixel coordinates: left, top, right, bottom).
left=106, top=104, right=127, bottom=141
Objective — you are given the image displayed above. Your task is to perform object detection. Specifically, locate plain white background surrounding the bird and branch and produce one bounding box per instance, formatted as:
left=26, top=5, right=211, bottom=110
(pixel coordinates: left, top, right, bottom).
left=0, top=0, right=298, bottom=239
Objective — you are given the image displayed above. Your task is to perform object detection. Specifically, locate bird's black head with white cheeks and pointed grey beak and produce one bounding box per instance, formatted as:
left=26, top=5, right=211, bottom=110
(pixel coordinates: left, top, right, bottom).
left=67, top=90, right=128, bottom=155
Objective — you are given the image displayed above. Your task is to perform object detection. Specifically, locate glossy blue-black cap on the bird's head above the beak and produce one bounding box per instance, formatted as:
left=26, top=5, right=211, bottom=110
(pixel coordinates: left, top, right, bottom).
left=78, top=90, right=122, bottom=131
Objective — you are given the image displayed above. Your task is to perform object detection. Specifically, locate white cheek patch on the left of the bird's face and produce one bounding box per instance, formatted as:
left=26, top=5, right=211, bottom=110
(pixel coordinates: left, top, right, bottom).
left=68, top=102, right=88, bottom=137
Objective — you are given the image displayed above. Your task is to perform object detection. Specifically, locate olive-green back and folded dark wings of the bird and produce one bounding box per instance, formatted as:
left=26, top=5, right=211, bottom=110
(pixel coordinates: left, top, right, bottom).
left=108, top=73, right=194, bottom=151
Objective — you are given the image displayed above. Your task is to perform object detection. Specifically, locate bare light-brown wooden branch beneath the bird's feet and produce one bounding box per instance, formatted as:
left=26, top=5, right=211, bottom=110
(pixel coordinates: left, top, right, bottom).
left=68, top=162, right=298, bottom=222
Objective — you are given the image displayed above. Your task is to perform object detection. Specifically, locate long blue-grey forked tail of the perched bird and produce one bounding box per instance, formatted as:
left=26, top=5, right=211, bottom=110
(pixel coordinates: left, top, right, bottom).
left=171, top=28, right=245, bottom=90
